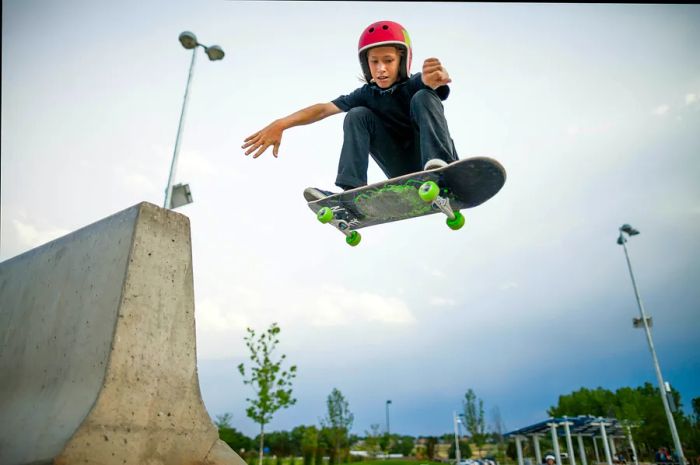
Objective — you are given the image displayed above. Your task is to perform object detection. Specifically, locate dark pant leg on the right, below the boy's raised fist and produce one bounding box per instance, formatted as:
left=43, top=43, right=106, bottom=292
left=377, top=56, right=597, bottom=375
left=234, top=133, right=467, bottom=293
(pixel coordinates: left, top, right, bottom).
left=411, top=89, right=459, bottom=169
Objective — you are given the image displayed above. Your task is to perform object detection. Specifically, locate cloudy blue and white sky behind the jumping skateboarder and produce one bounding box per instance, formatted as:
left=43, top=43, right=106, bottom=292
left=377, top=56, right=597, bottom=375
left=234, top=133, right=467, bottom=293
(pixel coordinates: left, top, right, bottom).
left=0, top=0, right=700, bottom=436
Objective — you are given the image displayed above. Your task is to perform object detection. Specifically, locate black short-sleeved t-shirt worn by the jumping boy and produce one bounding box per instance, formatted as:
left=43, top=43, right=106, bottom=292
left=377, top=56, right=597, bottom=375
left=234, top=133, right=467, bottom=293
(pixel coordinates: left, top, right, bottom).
left=332, top=73, right=450, bottom=135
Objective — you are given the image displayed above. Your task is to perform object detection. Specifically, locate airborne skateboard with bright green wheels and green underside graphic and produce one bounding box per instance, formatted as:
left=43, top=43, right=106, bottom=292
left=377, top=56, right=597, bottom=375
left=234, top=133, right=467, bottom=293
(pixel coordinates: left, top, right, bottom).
left=308, top=157, right=506, bottom=247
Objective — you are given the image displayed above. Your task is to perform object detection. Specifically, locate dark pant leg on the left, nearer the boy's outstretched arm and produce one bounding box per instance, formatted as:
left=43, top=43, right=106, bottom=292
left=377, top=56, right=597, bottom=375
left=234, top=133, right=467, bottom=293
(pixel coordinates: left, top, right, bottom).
left=335, top=107, right=420, bottom=189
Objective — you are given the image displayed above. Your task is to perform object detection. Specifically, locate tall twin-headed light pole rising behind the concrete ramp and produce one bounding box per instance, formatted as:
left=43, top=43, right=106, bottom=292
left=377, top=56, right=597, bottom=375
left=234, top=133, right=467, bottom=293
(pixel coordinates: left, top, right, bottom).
left=163, top=31, right=224, bottom=208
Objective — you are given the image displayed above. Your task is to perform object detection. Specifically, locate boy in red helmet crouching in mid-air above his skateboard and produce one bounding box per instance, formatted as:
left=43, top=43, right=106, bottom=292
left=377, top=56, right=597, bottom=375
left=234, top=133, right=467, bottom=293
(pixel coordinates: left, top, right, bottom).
left=242, top=21, right=458, bottom=201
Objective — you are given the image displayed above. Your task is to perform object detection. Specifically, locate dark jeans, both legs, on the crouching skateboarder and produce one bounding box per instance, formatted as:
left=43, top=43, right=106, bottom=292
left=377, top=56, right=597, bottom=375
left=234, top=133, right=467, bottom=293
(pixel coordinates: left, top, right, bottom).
left=335, top=89, right=458, bottom=189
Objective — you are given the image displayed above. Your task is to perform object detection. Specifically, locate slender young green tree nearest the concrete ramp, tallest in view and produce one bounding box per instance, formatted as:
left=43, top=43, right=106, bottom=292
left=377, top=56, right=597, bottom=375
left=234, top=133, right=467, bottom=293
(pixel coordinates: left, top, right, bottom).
left=238, top=323, right=297, bottom=465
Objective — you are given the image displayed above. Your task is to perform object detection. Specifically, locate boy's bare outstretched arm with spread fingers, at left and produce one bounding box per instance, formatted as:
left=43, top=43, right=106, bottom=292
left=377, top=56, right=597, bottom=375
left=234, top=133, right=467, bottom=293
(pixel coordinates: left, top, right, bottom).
left=241, top=102, right=341, bottom=158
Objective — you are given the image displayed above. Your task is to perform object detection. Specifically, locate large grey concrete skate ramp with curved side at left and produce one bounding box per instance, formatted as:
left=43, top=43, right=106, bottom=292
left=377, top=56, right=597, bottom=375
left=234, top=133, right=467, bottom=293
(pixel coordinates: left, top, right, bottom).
left=0, top=203, right=244, bottom=465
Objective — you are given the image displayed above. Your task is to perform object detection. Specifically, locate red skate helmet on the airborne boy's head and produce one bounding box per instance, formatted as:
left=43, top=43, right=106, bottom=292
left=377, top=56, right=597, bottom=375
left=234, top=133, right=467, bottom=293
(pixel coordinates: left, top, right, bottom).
left=357, top=21, right=412, bottom=82
